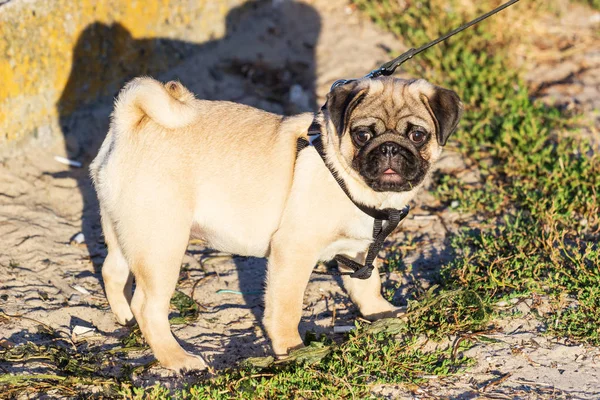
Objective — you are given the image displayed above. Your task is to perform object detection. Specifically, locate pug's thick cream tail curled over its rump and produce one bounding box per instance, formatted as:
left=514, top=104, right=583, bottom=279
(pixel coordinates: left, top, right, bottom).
left=113, top=77, right=198, bottom=131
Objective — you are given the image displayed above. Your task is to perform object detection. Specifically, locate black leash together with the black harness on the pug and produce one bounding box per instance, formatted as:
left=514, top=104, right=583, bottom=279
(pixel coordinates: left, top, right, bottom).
left=297, top=0, right=519, bottom=279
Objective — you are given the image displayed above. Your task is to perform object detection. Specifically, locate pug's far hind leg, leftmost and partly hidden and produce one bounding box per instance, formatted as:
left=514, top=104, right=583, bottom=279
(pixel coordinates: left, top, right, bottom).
left=102, top=214, right=134, bottom=325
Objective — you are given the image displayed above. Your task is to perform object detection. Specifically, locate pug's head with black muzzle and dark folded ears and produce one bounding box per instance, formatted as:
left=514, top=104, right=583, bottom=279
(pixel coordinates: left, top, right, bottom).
left=323, top=78, right=462, bottom=192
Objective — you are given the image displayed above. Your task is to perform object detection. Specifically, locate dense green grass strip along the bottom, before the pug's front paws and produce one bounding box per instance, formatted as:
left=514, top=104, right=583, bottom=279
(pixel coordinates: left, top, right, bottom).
left=121, top=319, right=470, bottom=399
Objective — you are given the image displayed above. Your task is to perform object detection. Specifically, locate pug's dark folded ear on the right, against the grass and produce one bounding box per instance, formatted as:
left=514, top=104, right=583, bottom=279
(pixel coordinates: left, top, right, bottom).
left=422, top=86, right=463, bottom=146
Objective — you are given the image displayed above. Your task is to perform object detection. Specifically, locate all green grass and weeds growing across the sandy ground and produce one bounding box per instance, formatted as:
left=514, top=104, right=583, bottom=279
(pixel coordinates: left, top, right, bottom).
left=0, top=0, right=600, bottom=399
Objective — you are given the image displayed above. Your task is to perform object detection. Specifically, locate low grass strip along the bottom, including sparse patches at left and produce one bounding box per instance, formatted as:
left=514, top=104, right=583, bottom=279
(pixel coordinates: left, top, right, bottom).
left=0, top=319, right=471, bottom=399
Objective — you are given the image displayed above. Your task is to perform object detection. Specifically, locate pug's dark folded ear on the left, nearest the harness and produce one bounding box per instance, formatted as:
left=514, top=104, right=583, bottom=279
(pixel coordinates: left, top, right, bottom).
left=323, top=81, right=369, bottom=136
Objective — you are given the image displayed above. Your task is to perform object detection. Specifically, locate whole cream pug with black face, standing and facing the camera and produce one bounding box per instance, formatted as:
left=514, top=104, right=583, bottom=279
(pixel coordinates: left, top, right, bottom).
left=90, top=77, right=462, bottom=371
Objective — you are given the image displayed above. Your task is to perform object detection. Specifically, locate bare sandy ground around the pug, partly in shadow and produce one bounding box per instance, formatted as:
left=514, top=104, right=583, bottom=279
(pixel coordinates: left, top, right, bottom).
left=0, top=0, right=600, bottom=399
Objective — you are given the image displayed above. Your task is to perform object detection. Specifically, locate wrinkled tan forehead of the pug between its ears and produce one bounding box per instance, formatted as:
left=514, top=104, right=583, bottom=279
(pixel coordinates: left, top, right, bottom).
left=350, top=78, right=435, bottom=133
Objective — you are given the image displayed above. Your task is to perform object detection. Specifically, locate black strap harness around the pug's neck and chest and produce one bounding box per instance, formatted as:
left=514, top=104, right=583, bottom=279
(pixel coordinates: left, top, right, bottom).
left=297, top=121, right=410, bottom=279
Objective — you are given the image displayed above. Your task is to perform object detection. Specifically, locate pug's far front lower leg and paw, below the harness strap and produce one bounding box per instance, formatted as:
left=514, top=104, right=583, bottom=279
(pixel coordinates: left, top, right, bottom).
left=340, top=253, right=404, bottom=320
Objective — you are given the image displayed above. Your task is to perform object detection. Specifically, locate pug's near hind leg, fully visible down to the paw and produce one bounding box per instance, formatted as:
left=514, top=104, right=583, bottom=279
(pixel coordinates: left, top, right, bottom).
left=126, top=211, right=206, bottom=371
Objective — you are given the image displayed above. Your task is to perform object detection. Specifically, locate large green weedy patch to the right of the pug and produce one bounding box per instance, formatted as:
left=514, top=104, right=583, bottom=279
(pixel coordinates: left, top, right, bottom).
left=357, top=0, right=600, bottom=344
